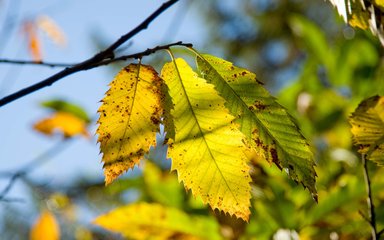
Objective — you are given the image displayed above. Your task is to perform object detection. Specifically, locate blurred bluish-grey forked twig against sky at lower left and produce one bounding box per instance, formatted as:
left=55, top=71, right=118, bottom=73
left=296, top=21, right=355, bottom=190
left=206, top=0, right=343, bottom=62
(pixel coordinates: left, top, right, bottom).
left=0, top=139, right=70, bottom=201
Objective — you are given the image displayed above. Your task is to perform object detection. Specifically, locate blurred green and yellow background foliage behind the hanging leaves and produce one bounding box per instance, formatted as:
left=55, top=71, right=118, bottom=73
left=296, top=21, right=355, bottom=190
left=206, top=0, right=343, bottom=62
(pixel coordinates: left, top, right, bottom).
left=1, top=0, right=384, bottom=239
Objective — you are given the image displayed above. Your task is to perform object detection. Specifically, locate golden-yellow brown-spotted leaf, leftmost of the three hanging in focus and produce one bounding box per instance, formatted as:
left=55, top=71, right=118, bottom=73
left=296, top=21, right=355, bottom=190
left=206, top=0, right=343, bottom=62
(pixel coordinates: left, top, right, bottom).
left=97, top=64, right=162, bottom=185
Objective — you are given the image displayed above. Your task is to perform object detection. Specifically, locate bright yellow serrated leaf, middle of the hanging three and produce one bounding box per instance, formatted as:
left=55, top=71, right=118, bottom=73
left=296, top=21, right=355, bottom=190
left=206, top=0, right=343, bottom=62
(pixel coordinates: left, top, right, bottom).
left=161, top=59, right=251, bottom=220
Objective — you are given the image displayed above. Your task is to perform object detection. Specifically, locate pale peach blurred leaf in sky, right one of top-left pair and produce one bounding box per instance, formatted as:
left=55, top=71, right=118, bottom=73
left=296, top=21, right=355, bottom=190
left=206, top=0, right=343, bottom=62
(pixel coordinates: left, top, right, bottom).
left=36, top=15, right=67, bottom=46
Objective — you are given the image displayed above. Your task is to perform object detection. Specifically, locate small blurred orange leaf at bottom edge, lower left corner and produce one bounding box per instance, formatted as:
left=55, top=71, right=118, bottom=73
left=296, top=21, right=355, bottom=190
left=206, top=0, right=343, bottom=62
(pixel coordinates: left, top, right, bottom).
left=29, top=211, right=60, bottom=240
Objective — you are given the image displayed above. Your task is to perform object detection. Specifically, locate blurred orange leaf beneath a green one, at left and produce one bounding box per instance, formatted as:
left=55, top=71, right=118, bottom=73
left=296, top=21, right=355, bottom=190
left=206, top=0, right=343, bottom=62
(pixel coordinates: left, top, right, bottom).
left=33, top=112, right=89, bottom=138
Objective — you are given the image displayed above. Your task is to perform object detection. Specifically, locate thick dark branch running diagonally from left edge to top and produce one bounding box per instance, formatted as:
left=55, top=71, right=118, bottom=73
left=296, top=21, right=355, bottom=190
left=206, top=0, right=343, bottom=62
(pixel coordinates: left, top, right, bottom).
left=0, top=0, right=179, bottom=107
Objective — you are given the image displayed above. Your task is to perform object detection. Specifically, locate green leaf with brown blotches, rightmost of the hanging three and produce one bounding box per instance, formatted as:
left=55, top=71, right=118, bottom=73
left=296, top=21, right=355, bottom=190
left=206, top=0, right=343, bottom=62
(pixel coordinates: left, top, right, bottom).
left=197, top=55, right=317, bottom=200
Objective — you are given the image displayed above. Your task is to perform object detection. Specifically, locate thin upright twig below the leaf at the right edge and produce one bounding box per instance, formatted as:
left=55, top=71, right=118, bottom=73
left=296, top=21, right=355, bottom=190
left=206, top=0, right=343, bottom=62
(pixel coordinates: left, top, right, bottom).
left=361, top=154, right=378, bottom=240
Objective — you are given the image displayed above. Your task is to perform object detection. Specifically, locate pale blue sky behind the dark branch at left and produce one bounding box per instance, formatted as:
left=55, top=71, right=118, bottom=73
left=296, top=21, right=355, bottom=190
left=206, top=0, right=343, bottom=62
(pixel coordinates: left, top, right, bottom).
left=0, top=0, right=205, bottom=223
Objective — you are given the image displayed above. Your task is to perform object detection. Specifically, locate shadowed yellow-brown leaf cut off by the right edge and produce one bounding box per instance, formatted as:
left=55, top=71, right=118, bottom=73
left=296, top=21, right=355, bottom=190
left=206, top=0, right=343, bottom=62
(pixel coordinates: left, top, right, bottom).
left=349, top=96, right=384, bottom=166
